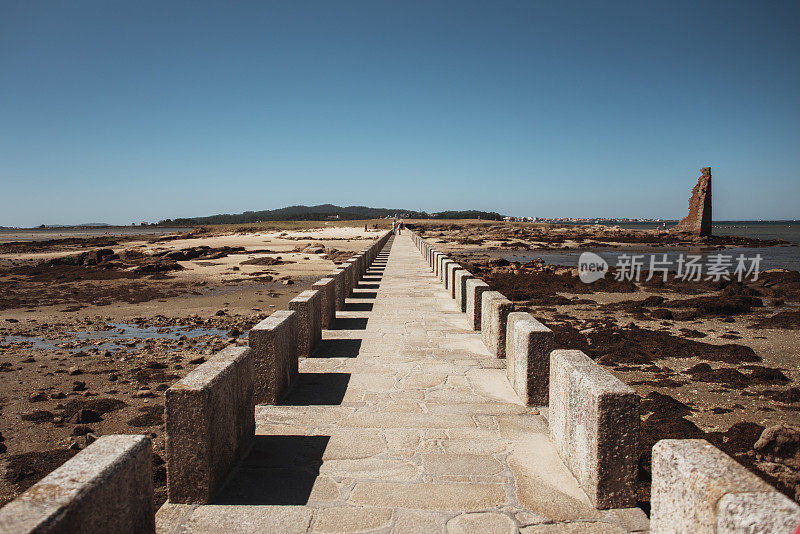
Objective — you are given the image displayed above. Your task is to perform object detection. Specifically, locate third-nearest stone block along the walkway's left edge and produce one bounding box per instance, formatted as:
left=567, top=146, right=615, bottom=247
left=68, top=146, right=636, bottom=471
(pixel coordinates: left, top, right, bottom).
left=247, top=310, right=298, bottom=404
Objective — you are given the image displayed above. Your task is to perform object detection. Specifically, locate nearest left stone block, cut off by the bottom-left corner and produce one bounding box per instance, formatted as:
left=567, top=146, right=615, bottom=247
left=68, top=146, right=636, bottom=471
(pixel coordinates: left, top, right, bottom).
left=0, top=434, right=156, bottom=534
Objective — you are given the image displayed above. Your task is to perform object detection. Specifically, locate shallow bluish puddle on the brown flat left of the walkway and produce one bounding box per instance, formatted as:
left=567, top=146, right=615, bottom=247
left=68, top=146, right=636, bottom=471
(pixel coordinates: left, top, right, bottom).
left=0, top=323, right=234, bottom=352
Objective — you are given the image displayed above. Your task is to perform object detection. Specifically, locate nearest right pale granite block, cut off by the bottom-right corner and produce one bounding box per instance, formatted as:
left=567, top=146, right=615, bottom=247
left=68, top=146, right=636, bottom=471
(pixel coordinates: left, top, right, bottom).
left=650, top=439, right=800, bottom=534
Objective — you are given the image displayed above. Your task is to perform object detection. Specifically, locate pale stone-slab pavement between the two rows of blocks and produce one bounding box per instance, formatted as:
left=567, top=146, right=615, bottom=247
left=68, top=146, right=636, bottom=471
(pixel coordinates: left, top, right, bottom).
left=156, top=234, right=648, bottom=534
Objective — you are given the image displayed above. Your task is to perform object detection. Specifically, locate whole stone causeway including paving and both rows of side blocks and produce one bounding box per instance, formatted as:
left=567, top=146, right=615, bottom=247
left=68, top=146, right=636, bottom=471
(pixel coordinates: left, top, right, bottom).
left=0, top=231, right=800, bottom=534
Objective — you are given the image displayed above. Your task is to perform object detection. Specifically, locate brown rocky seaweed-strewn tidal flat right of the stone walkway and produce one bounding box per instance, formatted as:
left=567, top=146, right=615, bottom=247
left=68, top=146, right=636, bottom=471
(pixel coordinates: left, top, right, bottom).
left=415, top=221, right=800, bottom=506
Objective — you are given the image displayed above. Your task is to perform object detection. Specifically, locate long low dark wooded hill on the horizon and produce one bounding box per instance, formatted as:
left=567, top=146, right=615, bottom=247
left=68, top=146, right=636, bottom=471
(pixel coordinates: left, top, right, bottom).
left=158, top=204, right=502, bottom=226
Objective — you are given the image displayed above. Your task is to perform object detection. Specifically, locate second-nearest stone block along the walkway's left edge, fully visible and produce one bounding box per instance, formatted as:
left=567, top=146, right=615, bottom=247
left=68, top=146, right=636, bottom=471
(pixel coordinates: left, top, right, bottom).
left=164, top=347, right=255, bottom=504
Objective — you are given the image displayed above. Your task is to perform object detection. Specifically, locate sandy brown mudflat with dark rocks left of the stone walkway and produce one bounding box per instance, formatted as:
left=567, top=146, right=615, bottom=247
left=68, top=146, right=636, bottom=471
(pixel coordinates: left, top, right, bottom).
left=0, top=221, right=386, bottom=506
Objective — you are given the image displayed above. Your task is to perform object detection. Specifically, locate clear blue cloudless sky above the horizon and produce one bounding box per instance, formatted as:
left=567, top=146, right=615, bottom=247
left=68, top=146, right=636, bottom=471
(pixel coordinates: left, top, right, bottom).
left=0, top=0, right=800, bottom=226
